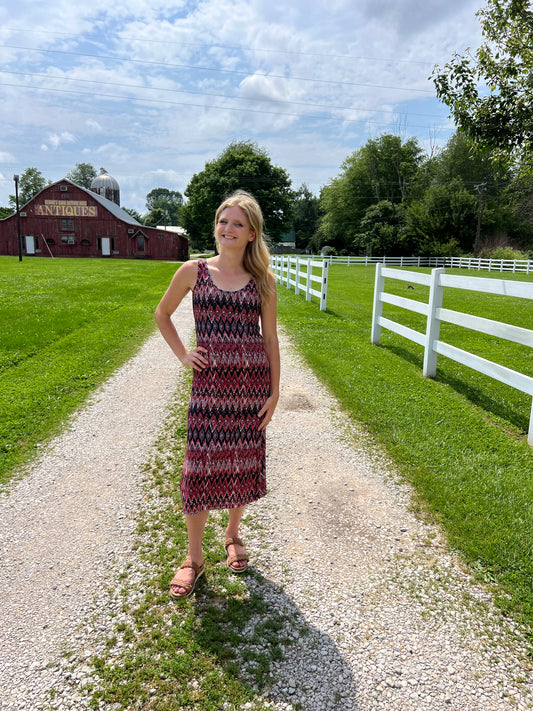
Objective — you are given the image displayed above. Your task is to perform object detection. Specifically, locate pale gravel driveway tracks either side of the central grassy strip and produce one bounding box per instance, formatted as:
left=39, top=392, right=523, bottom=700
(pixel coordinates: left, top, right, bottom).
left=0, top=292, right=533, bottom=711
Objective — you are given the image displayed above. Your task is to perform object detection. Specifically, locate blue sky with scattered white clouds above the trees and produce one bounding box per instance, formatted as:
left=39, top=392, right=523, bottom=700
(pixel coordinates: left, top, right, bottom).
left=0, top=0, right=483, bottom=214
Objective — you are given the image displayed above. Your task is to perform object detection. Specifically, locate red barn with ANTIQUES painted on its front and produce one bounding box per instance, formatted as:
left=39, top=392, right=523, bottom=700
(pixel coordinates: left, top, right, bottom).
left=0, top=178, right=189, bottom=261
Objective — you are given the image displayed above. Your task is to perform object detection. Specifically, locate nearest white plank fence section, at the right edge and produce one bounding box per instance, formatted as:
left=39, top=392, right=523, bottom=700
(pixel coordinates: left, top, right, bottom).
left=371, top=264, right=533, bottom=446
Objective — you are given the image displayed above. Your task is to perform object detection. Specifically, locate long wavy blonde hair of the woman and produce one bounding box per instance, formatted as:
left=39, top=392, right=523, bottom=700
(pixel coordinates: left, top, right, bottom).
left=215, top=190, right=276, bottom=304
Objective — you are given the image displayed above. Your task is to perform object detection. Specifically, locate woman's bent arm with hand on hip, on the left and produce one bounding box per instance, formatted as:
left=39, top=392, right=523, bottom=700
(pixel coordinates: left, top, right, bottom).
left=155, top=261, right=207, bottom=370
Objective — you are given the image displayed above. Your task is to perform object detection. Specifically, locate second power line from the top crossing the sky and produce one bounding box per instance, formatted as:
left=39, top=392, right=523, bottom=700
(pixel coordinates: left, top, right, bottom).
left=0, top=44, right=435, bottom=95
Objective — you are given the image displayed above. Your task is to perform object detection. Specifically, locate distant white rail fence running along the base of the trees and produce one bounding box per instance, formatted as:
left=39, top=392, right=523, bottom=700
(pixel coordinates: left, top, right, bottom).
left=274, top=256, right=533, bottom=274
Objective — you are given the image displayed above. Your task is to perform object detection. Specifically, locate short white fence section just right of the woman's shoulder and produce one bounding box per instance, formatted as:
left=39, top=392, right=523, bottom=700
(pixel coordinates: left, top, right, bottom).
left=270, top=254, right=329, bottom=311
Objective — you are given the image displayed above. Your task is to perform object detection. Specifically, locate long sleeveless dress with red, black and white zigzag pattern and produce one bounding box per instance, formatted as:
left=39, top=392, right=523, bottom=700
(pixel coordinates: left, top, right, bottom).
left=180, top=260, right=270, bottom=514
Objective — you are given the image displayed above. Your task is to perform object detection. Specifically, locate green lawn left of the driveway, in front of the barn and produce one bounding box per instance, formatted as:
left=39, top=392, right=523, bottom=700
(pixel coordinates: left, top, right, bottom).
left=0, top=257, right=177, bottom=484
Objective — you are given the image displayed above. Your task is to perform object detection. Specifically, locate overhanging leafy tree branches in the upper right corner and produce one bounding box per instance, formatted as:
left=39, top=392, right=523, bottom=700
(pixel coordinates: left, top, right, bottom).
left=432, top=0, right=533, bottom=167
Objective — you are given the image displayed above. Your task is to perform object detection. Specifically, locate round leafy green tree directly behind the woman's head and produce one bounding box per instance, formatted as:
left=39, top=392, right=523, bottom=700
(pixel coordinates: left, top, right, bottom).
left=182, top=141, right=293, bottom=248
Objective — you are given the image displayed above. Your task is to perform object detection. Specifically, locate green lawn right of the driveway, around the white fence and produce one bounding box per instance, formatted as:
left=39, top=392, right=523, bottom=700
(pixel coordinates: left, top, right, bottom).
left=278, top=266, right=533, bottom=624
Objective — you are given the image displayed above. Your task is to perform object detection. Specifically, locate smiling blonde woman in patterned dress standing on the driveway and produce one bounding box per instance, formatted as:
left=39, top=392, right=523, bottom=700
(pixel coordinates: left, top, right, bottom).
left=156, top=191, right=280, bottom=599
